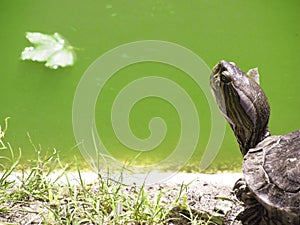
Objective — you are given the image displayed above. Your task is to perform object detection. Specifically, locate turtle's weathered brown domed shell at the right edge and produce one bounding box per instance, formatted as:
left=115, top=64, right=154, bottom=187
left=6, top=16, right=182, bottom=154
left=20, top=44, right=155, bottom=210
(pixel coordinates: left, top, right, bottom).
left=243, top=130, right=300, bottom=225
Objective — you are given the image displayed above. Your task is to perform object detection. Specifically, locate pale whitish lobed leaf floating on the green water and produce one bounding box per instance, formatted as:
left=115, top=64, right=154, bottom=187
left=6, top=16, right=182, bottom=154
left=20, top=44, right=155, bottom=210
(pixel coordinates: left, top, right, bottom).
left=21, top=32, right=76, bottom=69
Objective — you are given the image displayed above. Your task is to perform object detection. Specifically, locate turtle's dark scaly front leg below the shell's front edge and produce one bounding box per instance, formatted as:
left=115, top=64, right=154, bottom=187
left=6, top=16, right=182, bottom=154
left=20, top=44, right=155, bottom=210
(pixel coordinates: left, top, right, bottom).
left=233, top=178, right=264, bottom=225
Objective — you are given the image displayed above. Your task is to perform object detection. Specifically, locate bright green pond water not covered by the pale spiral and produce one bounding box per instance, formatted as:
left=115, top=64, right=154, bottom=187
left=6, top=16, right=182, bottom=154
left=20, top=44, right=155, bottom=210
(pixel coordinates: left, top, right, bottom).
left=0, top=0, right=300, bottom=171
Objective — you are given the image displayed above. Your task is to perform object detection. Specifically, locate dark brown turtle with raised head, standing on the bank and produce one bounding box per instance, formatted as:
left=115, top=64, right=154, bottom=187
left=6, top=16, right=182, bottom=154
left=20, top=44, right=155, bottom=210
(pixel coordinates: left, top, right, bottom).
left=210, top=60, right=300, bottom=225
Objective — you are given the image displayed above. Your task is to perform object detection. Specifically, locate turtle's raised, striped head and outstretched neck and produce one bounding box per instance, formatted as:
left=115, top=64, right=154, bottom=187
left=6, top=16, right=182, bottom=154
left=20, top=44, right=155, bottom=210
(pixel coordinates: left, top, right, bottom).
left=210, top=60, right=270, bottom=156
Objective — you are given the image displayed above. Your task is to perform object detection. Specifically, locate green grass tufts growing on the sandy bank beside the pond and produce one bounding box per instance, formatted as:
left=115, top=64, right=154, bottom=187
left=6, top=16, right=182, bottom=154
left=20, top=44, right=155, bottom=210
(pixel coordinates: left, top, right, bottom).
left=0, top=140, right=222, bottom=225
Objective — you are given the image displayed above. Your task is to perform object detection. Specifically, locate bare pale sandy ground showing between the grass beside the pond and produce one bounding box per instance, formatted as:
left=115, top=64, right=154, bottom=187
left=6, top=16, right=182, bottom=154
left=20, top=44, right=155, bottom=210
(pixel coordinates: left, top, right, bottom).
left=0, top=171, right=242, bottom=225
